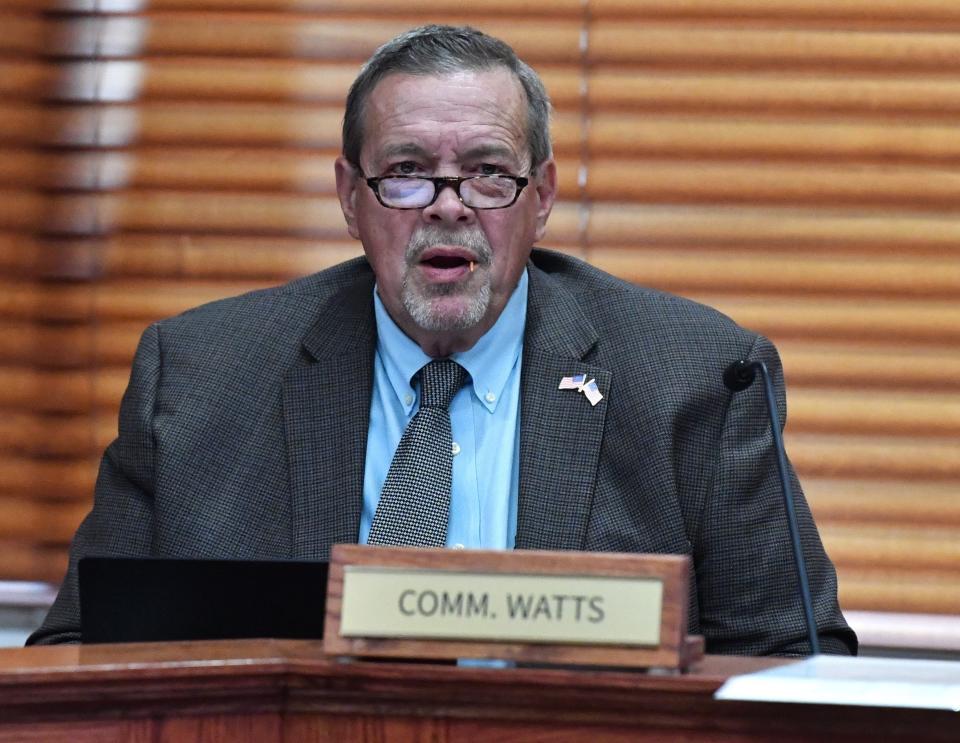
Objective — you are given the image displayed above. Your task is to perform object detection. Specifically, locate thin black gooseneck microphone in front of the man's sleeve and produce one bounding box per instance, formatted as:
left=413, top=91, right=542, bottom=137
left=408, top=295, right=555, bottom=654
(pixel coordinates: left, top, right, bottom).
left=723, top=359, right=820, bottom=655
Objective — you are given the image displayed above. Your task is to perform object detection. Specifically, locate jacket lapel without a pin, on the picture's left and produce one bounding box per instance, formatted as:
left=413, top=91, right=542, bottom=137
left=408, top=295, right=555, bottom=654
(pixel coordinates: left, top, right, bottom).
left=283, top=271, right=376, bottom=560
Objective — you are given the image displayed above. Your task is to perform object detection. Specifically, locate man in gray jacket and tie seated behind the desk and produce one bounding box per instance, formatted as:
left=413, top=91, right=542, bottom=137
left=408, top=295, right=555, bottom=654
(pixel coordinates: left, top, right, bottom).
left=32, top=21, right=856, bottom=653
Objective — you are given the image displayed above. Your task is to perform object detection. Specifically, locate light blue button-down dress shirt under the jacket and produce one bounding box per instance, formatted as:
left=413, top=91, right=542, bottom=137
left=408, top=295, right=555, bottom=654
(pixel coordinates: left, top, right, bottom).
left=359, top=271, right=527, bottom=549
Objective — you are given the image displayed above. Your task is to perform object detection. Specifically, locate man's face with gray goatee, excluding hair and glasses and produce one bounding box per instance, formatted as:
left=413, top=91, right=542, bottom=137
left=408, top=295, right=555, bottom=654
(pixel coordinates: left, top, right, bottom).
left=337, top=69, right=556, bottom=353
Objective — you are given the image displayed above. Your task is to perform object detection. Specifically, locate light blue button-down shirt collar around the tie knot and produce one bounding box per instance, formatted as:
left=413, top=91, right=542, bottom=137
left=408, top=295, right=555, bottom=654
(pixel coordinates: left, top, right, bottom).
left=373, top=269, right=528, bottom=414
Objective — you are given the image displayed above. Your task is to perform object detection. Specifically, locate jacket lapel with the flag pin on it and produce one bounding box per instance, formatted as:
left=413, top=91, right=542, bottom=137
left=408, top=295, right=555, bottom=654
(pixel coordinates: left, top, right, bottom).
left=516, top=265, right=611, bottom=550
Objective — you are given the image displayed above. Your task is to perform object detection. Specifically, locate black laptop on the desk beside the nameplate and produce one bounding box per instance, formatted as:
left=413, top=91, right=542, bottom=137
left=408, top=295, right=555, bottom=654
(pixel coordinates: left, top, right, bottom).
left=79, top=557, right=327, bottom=643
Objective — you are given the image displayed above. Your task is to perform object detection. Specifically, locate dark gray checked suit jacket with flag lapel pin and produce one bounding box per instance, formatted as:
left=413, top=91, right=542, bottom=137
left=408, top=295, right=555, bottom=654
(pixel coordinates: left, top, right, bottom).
left=31, top=250, right=856, bottom=654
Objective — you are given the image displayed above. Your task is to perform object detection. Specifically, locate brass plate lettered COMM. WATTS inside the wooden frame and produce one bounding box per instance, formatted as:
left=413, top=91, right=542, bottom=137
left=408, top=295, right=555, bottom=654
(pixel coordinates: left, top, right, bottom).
left=340, top=565, right=663, bottom=647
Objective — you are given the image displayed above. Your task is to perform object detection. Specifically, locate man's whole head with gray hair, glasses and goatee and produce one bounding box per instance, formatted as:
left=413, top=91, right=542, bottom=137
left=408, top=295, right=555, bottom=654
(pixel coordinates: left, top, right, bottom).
left=336, top=26, right=556, bottom=355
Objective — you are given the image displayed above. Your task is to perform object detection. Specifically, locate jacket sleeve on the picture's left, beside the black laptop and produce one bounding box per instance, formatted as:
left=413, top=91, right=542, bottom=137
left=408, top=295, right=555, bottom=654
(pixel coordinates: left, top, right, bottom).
left=27, top=325, right=161, bottom=645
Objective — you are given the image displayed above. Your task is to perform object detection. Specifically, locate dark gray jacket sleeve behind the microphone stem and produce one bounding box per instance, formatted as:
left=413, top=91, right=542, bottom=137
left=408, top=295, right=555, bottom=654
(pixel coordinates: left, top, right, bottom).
left=694, top=337, right=856, bottom=654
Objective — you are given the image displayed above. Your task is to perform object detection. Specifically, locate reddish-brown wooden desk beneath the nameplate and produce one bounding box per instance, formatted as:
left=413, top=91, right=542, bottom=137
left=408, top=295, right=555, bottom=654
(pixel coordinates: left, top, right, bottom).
left=0, top=640, right=960, bottom=743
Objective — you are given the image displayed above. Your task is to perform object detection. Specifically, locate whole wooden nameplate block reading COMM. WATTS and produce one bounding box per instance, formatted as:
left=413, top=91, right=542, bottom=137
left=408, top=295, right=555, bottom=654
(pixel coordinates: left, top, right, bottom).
left=324, top=544, right=703, bottom=669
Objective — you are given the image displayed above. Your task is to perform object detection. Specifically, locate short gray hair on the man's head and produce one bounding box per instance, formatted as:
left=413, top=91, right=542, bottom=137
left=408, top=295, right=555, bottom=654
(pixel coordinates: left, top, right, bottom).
left=343, top=25, right=552, bottom=170
